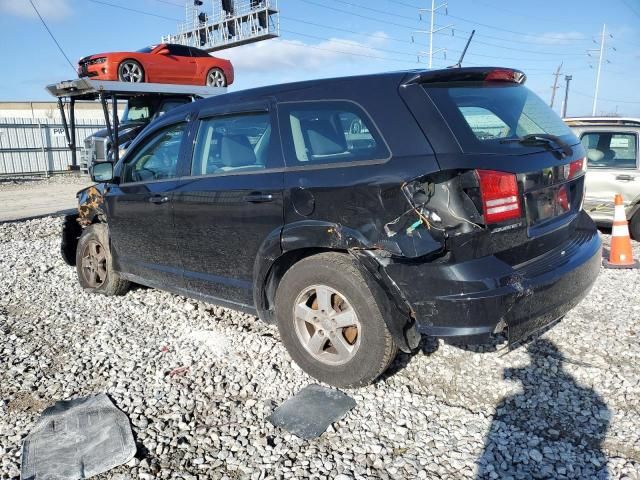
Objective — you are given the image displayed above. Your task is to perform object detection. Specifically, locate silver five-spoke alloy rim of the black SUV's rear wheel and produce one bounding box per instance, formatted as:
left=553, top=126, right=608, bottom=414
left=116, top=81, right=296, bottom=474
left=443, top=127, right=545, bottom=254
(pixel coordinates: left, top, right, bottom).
left=293, top=285, right=362, bottom=365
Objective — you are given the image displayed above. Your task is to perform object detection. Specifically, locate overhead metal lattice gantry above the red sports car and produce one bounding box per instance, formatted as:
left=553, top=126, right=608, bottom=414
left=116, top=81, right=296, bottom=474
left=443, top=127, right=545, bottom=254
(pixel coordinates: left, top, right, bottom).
left=162, top=0, right=280, bottom=52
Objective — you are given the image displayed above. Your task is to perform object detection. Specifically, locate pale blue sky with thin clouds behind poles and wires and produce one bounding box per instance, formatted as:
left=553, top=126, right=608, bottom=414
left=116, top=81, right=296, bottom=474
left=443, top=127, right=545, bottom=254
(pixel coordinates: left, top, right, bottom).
left=0, top=0, right=640, bottom=116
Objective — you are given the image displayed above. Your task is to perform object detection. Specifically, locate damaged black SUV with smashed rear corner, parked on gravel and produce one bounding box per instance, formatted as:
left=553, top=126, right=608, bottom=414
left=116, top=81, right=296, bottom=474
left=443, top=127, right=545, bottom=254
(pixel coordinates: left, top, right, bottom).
left=62, top=68, right=601, bottom=386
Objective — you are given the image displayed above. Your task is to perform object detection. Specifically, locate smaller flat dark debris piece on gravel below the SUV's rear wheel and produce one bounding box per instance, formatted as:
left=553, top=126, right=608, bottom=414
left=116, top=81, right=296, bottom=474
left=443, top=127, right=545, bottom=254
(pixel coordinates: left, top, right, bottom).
left=268, top=385, right=356, bottom=440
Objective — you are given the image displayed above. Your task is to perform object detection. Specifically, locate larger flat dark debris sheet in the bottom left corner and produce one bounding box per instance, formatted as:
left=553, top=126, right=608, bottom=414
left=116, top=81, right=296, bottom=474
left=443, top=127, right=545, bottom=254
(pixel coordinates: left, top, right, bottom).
left=21, top=394, right=136, bottom=480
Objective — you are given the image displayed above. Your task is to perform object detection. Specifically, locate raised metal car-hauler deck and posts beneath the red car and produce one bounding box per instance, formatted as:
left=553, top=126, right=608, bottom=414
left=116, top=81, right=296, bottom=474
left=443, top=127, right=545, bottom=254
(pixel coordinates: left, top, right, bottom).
left=46, top=78, right=227, bottom=170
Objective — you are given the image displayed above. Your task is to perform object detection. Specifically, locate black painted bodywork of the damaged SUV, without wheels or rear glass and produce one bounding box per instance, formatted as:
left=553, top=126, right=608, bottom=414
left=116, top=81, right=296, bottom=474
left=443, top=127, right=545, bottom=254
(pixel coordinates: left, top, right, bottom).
left=67, top=69, right=600, bottom=351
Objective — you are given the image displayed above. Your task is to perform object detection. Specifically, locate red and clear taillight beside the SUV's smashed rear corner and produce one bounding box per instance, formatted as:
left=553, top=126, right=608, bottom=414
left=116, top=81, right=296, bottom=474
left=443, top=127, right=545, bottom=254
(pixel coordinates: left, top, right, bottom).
left=477, top=170, right=522, bottom=224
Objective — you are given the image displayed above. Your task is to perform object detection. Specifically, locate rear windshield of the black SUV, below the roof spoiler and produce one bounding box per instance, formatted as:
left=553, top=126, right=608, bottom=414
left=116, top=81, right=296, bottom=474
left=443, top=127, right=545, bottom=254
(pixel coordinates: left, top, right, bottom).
left=425, top=83, right=578, bottom=153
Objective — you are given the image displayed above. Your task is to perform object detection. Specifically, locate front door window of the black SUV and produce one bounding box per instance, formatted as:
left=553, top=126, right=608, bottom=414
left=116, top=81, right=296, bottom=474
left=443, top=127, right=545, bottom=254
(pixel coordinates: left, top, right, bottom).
left=123, top=123, right=185, bottom=183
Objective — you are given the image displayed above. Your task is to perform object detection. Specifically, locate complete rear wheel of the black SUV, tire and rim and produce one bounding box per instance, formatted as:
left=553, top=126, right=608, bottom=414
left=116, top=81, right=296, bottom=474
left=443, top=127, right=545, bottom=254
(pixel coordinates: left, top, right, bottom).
left=276, top=252, right=398, bottom=387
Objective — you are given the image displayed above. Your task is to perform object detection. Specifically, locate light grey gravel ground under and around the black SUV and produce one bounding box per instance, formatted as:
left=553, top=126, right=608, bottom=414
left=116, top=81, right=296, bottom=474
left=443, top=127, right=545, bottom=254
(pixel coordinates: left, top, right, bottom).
left=0, top=218, right=640, bottom=480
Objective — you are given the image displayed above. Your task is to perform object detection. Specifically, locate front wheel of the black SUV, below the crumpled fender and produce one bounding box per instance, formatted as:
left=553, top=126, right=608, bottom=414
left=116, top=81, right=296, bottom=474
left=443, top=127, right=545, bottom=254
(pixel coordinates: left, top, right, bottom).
left=76, top=223, right=131, bottom=296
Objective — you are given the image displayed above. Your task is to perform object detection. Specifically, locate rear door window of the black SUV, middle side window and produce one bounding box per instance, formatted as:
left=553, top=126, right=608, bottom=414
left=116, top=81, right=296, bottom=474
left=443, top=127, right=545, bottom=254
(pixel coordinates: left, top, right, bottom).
left=191, top=113, right=271, bottom=175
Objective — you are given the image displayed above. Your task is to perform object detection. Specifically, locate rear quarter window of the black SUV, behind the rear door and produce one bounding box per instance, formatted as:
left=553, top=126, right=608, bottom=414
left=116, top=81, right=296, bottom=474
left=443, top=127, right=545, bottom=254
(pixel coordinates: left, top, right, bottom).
left=280, top=101, right=389, bottom=166
